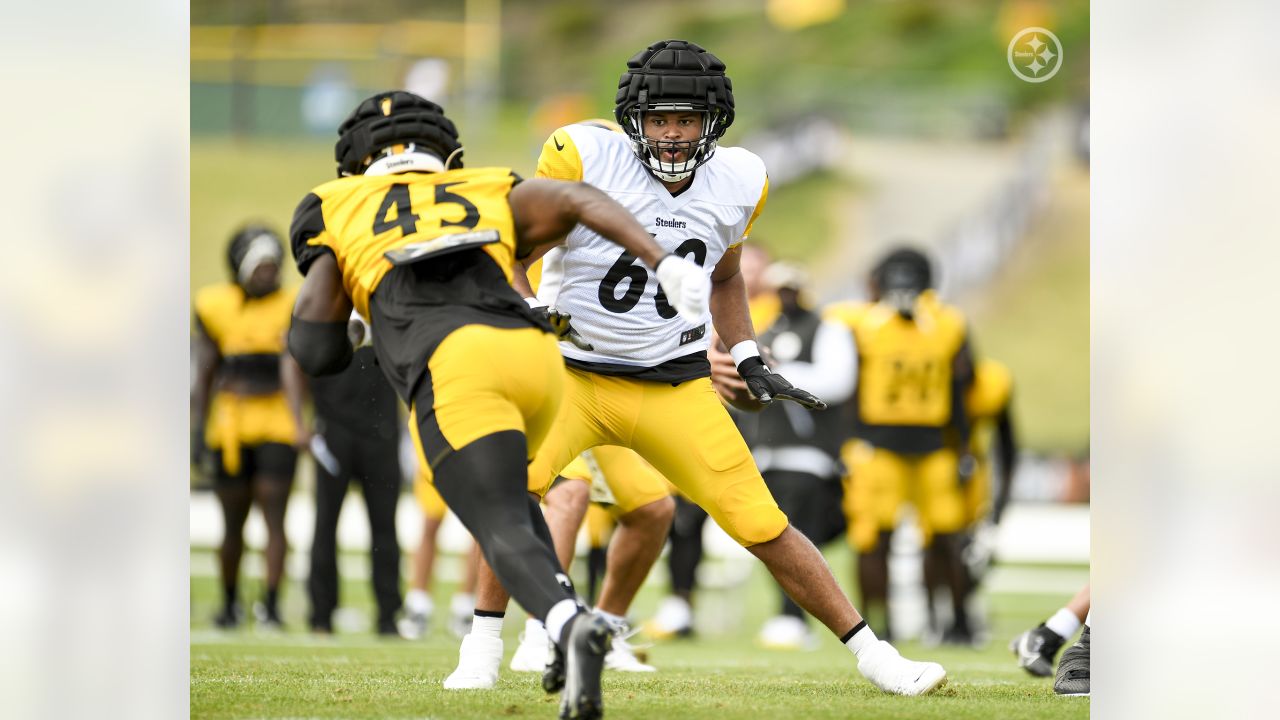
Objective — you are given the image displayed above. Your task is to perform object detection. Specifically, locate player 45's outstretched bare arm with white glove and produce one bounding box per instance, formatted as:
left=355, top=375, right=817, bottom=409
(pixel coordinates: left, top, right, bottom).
left=508, top=178, right=710, bottom=322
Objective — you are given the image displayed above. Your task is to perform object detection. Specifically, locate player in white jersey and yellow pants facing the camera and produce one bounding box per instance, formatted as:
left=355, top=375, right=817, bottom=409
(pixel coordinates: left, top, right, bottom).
left=445, top=40, right=946, bottom=696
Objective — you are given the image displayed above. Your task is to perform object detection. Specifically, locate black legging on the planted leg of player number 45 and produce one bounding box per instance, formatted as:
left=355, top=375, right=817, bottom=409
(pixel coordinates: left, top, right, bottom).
left=435, top=430, right=575, bottom=620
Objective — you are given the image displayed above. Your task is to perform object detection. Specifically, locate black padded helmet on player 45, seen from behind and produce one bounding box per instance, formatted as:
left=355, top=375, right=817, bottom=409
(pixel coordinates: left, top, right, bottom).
left=333, top=90, right=462, bottom=177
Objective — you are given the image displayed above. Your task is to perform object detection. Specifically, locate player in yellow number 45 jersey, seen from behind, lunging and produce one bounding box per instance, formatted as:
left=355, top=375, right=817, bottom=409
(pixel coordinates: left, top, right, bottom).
left=289, top=91, right=709, bottom=717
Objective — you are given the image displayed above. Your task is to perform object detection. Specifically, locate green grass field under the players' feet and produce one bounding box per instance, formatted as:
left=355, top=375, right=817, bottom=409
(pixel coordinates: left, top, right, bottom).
left=191, top=543, right=1089, bottom=720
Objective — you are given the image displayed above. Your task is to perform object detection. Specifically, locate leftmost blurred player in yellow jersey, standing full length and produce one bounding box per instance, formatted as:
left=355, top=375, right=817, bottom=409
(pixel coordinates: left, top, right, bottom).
left=191, top=224, right=310, bottom=629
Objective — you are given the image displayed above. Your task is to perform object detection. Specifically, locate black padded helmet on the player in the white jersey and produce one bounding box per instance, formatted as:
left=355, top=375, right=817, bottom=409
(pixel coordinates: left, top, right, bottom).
left=613, top=40, right=733, bottom=182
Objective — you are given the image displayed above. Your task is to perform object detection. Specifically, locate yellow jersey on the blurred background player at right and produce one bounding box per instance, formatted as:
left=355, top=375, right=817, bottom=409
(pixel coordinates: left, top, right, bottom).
left=826, top=292, right=968, bottom=452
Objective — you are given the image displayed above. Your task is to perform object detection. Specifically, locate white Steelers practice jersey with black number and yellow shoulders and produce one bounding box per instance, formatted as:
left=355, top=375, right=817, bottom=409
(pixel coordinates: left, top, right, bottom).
left=538, top=126, right=768, bottom=368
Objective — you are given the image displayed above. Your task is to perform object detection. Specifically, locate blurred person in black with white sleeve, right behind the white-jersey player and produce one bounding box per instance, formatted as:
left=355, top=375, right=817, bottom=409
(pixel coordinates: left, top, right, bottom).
left=737, top=261, right=858, bottom=650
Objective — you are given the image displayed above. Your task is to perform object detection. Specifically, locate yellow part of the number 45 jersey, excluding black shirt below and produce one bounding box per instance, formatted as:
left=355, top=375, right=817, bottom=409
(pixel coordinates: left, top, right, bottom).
left=289, top=168, right=520, bottom=318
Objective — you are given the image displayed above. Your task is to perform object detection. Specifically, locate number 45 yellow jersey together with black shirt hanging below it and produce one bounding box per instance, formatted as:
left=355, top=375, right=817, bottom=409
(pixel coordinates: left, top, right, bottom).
left=289, top=168, right=550, bottom=402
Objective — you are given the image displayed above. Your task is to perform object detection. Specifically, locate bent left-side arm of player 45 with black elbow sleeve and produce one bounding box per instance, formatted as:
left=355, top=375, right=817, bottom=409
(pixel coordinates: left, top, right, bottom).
left=289, top=252, right=353, bottom=375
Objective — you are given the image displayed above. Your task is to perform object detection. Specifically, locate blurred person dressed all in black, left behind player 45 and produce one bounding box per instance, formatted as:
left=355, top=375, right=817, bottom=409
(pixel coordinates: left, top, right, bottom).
left=307, top=315, right=401, bottom=635
